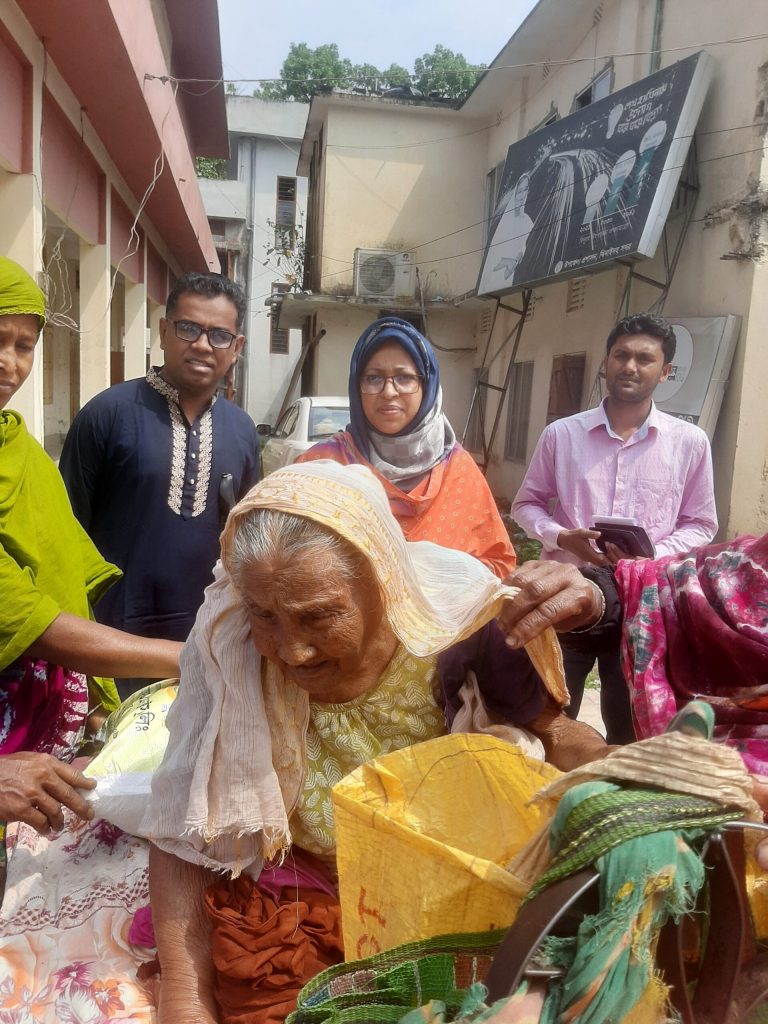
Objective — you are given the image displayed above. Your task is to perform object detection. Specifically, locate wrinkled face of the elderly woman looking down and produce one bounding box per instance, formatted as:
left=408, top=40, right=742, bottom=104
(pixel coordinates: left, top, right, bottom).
left=239, top=547, right=396, bottom=702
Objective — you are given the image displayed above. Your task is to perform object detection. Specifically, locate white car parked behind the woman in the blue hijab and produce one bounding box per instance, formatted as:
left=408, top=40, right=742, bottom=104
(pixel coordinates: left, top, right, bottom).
left=256, top=396, right=349, bottom=476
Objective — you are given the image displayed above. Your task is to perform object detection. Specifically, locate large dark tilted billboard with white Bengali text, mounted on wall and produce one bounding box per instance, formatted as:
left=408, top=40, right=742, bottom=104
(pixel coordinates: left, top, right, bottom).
left=477, top=52, right=714, bottom=295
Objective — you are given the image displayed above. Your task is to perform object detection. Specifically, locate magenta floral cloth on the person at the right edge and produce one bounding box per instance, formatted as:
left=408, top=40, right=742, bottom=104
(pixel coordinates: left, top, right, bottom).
left=615, top=535, right=768, bottom=775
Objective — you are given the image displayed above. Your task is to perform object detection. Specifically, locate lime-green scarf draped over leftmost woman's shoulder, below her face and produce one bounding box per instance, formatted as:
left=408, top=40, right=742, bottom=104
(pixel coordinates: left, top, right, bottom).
left=0, top=410, right=121, bottom=711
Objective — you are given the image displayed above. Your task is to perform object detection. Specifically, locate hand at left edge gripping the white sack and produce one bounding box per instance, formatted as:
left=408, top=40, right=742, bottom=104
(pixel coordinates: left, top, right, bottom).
left=0, top=753, right=96, bottom=836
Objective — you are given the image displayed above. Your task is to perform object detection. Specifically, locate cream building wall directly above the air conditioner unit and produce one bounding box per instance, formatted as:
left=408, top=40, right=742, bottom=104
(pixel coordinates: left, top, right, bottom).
left=321, top=97, right=485, bottom=298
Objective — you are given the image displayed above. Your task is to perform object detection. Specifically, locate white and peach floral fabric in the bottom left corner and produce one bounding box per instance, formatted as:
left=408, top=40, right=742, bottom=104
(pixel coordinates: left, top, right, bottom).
left=0, top=816, right=156, bottom=1024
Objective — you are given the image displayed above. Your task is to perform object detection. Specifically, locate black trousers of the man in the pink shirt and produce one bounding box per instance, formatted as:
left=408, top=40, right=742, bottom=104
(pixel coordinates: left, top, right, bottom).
left=562, top=641, right=635, bottom=743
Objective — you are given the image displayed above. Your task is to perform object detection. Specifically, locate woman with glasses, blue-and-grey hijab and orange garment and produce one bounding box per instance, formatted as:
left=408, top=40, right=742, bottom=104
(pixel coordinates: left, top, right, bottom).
left=298, top=316, right=515, bottom=579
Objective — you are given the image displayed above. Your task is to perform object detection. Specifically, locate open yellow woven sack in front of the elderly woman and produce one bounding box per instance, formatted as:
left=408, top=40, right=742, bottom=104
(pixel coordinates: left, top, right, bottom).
left=333, top=733, right=560, bottom=961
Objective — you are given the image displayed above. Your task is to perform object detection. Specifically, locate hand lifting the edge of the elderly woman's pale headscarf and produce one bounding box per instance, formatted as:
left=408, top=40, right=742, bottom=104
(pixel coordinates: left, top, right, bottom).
left=498, top=562, right=603, bottom=647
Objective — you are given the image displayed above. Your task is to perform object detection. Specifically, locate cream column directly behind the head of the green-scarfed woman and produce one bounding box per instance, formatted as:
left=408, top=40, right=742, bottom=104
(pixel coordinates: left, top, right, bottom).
left=0, top=172, right=44, bottom=443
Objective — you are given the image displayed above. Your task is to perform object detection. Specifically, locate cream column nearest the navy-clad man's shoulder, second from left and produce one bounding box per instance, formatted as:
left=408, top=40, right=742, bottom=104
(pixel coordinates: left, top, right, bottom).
left=80, top=235, right=112, bottom=409
